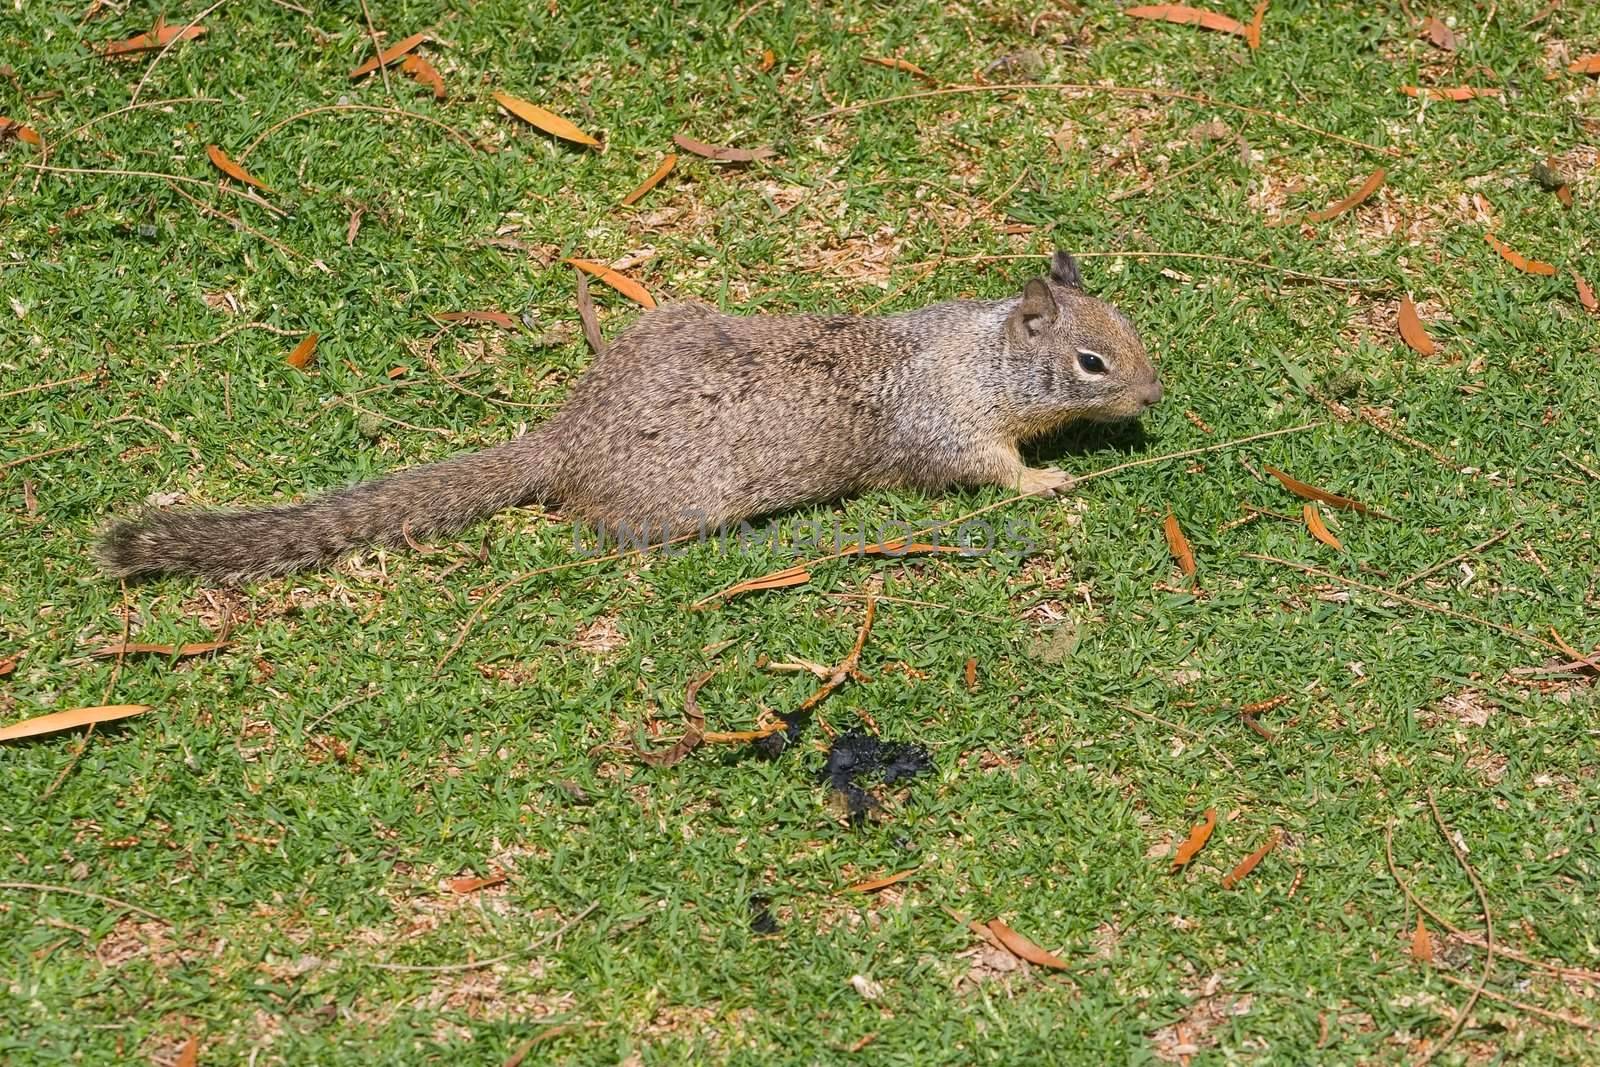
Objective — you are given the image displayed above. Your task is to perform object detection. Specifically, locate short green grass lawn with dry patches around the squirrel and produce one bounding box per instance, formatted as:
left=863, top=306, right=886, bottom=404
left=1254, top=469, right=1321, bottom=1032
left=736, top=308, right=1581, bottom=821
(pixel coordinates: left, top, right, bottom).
left=0, top=0, right=1600, bottom=1064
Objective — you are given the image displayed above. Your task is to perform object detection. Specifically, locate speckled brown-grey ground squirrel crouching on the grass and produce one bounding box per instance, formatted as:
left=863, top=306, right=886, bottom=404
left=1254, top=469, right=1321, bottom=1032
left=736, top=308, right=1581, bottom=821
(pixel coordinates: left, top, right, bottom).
left=98, top=251, right=1162, bottom=582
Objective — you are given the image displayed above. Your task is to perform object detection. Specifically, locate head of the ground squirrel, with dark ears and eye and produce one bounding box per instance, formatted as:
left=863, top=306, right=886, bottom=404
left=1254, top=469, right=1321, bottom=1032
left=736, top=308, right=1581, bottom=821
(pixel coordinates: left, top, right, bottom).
left=1005, top=251, right=1162, bottom=421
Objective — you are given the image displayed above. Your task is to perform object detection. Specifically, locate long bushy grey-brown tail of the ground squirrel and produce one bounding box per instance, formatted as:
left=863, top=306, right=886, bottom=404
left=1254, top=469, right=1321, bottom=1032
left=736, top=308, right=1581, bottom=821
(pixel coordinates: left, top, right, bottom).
left=98, top=427, right=557, bottom=582
